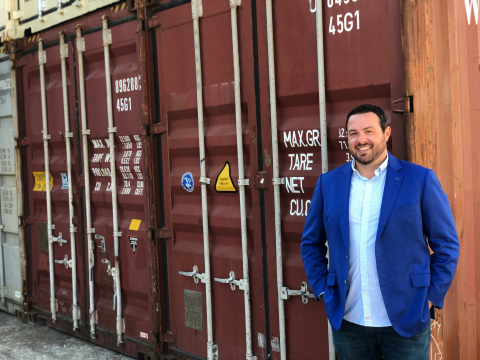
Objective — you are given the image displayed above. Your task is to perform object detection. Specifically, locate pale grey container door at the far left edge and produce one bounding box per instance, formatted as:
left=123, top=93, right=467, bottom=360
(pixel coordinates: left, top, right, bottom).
left=0, top=48, right=23, bottom=313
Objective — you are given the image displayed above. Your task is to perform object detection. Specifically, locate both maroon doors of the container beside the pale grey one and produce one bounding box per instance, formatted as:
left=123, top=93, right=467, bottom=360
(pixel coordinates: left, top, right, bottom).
left=17, top=5, right=158, bottom=357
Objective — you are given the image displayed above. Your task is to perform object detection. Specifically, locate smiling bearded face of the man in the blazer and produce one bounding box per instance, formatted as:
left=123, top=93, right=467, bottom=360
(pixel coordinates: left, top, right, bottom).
left=347, top=113, right=391, bottom=165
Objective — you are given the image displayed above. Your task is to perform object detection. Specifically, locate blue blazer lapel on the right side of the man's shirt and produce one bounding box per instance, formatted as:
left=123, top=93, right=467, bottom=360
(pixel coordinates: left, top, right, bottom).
left=376, top=153, right=403, bottom=240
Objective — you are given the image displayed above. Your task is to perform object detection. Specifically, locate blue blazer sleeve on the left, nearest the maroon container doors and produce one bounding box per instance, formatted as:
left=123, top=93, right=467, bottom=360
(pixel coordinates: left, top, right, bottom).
left=300, top=175, right=328, bottom=298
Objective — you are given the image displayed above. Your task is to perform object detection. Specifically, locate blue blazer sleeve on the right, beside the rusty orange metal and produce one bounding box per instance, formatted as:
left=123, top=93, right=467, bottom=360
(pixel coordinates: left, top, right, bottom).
left=422, top=170, right=460, bottom=308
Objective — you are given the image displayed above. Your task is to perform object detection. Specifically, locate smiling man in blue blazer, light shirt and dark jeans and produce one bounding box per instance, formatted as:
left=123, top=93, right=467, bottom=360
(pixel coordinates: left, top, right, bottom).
left=301, top=104, right=460, bottom=360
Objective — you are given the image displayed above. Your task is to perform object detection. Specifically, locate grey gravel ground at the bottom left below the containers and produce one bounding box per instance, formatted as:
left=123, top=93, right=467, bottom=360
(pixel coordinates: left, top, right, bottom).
left=0, top=311, right=132, bottom=360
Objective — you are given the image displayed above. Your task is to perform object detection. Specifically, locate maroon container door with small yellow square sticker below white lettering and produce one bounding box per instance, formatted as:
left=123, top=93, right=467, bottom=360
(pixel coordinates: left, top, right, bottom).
left=82, top=16, right=157, bottom=353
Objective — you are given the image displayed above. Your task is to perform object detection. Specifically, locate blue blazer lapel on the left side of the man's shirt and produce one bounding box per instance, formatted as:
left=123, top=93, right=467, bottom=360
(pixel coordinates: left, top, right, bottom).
left=337, top=163, right=352, bottom=253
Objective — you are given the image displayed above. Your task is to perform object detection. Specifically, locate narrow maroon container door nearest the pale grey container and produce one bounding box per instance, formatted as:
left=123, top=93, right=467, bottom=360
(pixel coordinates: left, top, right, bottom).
left=19, top=39, right=87, bottom=322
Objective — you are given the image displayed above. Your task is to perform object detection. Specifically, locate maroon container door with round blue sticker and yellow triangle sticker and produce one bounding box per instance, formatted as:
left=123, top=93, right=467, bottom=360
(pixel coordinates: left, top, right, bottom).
left=154, top=1, right=267, bottom=359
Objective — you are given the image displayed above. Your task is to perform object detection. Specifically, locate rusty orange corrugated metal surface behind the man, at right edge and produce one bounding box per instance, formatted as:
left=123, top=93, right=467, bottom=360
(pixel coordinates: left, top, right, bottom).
left=402, top=1, right=480, bottom=360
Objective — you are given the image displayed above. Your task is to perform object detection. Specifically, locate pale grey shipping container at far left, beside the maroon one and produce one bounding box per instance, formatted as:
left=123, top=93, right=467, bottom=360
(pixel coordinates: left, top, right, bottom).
left=0, top=46, right=27, bottom=321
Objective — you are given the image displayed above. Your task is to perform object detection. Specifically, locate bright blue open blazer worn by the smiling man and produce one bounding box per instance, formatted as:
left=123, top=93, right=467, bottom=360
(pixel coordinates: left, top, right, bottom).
left=301, top=154, right=460, bottom=336
